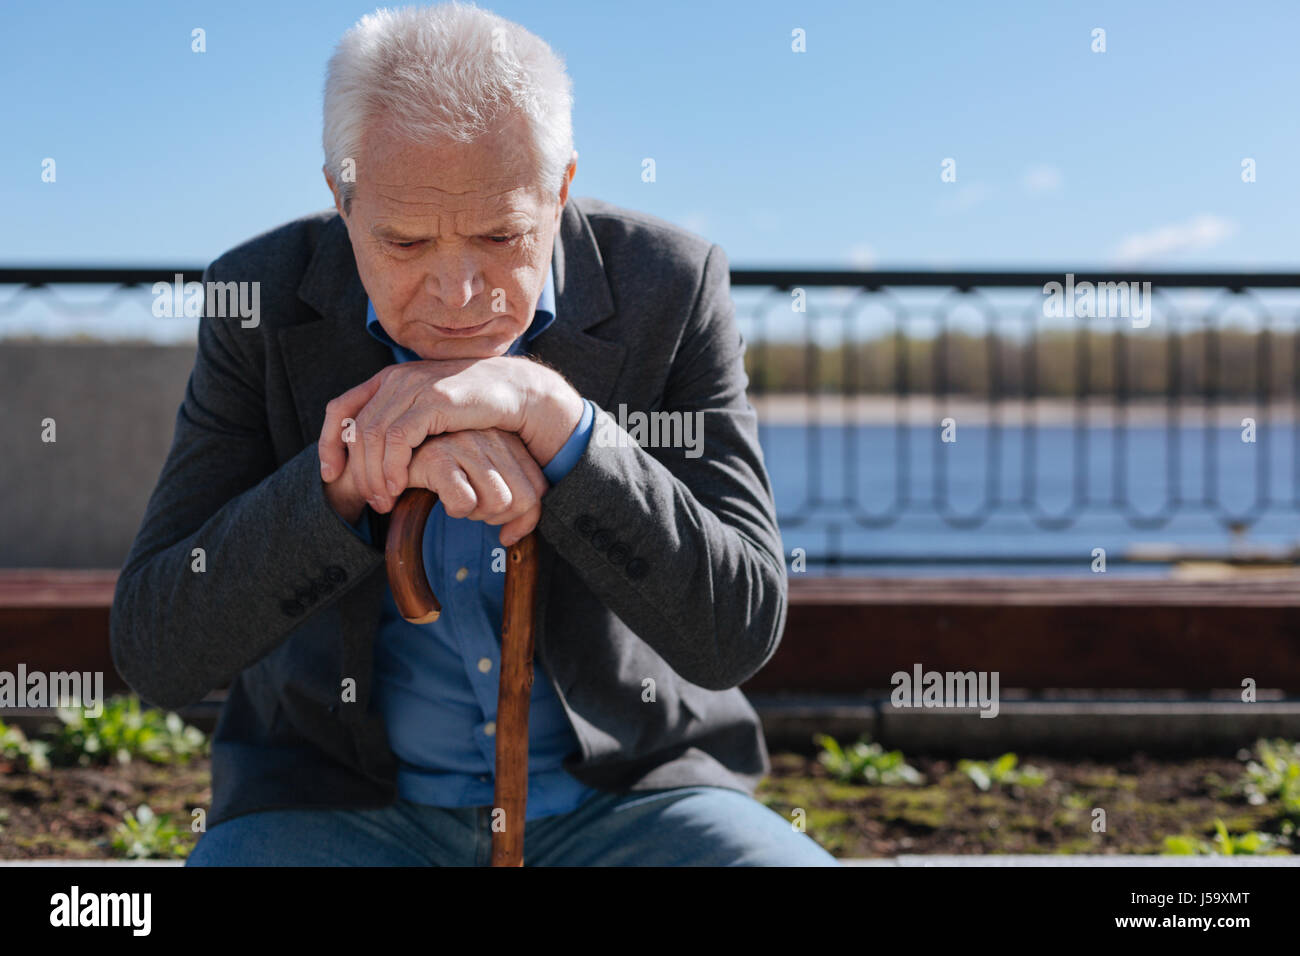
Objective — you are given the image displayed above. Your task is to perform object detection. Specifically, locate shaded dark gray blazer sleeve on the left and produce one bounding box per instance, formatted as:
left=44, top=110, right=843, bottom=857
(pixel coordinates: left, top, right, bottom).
left=109, top=260, right=384, bottom=708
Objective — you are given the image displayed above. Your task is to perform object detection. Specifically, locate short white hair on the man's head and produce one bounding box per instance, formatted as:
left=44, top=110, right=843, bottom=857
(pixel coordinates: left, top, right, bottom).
left=322, top=1, right=573, bottom=212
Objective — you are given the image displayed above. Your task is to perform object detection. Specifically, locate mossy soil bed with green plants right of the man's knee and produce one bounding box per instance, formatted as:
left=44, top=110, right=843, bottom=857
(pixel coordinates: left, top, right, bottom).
left=758, top=737, right=1297, bottom=857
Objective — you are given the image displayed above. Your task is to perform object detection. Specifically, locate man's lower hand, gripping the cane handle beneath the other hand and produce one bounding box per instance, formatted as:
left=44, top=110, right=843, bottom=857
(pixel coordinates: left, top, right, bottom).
left=325, top=428, right=547, bottom=548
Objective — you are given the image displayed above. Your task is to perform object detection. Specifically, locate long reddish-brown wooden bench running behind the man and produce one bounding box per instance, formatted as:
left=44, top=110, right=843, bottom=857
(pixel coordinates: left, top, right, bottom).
left=0, top=568, right=1300, bottom=696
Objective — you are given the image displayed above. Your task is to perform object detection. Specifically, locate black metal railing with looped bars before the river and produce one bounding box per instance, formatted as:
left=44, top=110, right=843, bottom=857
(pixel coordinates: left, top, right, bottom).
left=0, top=268, right=1300, bottom=567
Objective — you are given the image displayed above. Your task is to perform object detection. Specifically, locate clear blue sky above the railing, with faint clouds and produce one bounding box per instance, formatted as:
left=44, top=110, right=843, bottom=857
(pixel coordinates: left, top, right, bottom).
left=0, top=0, right=1300, bottom=269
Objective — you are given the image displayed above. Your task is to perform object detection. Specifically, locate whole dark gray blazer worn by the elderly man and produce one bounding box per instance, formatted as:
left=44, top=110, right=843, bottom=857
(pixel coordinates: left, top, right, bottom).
left=112, top=198, right=787, bottom=823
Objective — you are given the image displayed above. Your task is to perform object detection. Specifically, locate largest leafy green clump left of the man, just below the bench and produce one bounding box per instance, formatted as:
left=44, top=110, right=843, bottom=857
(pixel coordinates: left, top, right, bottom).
left=51, top=695, right=207, bottom=766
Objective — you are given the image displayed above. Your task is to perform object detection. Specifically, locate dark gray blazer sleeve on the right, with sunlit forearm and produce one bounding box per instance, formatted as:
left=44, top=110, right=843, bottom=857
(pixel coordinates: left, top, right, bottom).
left=540, top=245, right=788, bottom=689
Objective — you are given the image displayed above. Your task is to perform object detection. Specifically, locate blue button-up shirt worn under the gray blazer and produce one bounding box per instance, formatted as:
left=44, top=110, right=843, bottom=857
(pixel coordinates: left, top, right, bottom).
left=345, top=256, right=597, bottom=821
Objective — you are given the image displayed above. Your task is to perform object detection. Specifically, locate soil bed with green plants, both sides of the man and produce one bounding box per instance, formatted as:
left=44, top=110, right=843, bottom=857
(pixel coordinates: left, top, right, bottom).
left=0, top=698, right=1300, bottom=858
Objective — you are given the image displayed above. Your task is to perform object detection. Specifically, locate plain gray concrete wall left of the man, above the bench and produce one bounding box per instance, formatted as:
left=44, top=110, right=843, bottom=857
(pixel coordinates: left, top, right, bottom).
left=0, top=342, right=194, bottom=567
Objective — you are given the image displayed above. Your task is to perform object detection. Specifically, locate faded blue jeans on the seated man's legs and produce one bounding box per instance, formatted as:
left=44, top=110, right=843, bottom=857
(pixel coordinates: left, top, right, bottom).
left=186, top=787, right=840, bottom=866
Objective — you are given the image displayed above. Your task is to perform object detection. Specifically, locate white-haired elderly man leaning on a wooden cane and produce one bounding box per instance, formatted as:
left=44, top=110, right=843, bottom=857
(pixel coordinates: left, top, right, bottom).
left=112, top=4, right=835, bottom=865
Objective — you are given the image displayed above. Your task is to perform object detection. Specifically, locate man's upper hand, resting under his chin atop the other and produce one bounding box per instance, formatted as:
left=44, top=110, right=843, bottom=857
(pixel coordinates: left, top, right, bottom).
left=317, top=356, right=582, bottom=514
